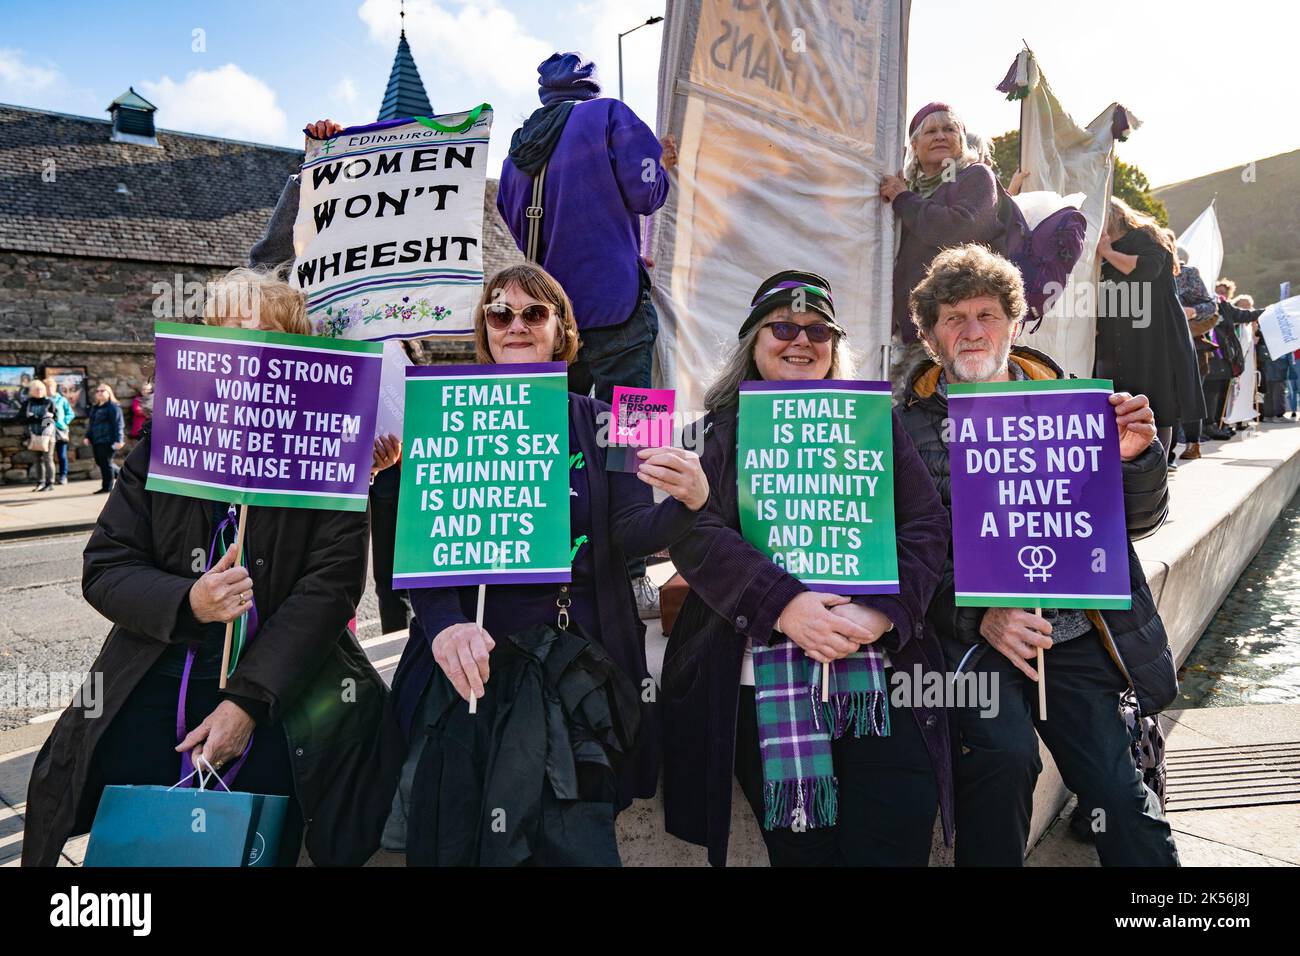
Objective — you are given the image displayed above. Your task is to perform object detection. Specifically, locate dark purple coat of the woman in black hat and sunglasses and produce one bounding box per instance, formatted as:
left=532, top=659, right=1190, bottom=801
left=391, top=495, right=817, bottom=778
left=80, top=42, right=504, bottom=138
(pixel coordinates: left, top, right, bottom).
left=660, top=408, right=953, bottom=866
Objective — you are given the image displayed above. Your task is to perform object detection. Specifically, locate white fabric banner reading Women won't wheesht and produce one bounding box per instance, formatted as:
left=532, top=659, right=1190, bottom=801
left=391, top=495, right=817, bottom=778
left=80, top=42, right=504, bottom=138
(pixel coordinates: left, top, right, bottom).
left=290, top=104, right=493, bottom=341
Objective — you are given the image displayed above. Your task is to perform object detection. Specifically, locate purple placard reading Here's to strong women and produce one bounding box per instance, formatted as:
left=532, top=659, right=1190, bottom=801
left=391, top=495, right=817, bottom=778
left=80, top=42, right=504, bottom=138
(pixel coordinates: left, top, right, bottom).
left=148, top=323, right=382, bottom=511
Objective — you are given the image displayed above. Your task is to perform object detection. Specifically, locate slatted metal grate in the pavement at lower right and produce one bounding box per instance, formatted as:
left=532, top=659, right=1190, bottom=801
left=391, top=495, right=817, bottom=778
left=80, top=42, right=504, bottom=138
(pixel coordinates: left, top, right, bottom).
left=1165, top=740, right=1300, bottom=813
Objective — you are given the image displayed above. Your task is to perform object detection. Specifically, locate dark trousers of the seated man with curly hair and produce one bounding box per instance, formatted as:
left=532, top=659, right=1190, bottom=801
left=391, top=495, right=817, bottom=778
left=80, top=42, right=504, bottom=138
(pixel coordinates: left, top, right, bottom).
left=948, top=631, right=1178, bottom=866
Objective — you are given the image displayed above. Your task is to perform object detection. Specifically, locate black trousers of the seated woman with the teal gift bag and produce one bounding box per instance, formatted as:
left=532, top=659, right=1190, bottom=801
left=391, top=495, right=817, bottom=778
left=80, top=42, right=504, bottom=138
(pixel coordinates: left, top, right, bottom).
left=91, top=674, right=303, bottom=866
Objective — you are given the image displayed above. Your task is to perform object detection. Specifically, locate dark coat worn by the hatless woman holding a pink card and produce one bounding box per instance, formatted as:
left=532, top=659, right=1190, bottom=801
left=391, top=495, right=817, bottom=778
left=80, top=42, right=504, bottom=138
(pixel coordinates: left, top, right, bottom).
left=393, top=394, right=697, bottom=805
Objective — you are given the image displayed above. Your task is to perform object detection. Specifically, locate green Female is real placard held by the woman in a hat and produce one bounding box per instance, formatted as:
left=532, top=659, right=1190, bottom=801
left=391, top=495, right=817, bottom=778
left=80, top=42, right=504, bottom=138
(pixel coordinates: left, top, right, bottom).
left=736, top=381, right=898, bottom=594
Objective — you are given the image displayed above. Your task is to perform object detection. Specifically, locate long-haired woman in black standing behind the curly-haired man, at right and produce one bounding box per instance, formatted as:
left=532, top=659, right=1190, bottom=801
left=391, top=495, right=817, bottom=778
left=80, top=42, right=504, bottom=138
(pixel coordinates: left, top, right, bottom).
left=1095, top=196, right=1205, bottom=454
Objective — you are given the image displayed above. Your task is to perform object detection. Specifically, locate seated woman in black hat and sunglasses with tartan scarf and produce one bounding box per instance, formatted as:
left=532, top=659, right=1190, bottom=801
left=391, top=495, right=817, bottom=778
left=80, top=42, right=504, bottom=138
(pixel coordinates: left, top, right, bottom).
left=660, top=272, right=952, bottom=866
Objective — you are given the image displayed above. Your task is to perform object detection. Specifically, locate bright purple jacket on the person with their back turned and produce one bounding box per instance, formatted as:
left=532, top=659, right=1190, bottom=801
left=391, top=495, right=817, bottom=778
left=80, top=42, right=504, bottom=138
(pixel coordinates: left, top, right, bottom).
left=497, top=98, right=668, bottom=329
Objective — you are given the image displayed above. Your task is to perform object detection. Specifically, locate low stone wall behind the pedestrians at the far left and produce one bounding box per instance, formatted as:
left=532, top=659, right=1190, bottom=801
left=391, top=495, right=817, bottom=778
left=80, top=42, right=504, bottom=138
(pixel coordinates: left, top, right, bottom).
left=0, top=338, right=153, bottom=484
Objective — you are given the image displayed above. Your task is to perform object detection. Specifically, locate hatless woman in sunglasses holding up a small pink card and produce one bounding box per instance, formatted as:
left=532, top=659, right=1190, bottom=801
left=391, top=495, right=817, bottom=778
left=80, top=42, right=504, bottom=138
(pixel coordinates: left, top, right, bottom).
left=385, top=263, right=709, bottom=849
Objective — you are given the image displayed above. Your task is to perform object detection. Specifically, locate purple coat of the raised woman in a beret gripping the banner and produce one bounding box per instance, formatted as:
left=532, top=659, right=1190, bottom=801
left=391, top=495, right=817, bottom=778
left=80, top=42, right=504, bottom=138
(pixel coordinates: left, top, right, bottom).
left=893, top=163, right=1028, bottom=342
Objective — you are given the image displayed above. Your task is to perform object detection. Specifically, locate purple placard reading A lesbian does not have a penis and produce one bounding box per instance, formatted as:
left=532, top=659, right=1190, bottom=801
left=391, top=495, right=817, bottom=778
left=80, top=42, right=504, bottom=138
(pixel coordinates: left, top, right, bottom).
left=948, top=380, right=1132, bottom=607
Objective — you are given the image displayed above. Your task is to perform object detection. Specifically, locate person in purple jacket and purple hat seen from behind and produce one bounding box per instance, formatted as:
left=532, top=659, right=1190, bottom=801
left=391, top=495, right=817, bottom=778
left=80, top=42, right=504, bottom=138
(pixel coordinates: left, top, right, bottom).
left=497, top=53, right=677, bottom=618
